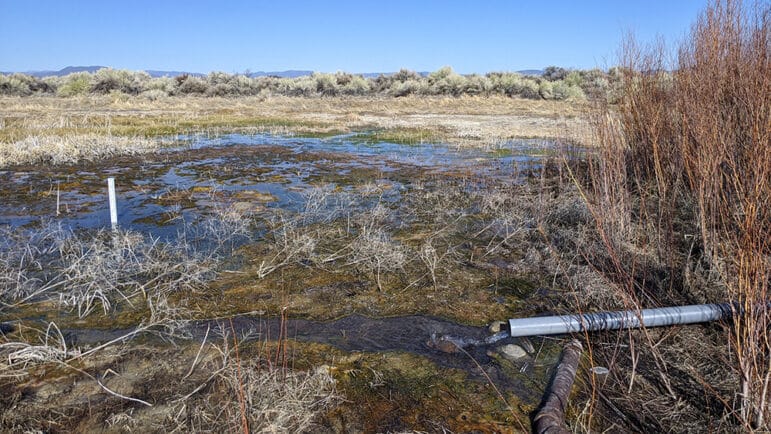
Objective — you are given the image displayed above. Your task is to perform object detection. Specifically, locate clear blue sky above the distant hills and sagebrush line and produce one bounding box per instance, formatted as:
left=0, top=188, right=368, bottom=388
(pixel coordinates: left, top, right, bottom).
left=0, top=0, right=707, bottom=73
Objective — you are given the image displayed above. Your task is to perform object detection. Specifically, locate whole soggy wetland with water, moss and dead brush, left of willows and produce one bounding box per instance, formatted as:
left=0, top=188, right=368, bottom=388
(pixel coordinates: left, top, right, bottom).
left=0, top=123, right=580, bottom=432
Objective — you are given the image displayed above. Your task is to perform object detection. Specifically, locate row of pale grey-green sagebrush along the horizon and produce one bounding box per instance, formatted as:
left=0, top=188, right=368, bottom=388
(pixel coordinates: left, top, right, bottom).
left=0, top=66, right=622, bottom=100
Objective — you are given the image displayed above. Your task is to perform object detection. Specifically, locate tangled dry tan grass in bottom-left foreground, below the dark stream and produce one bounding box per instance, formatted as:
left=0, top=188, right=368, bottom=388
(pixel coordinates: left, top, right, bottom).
left=0, top=322, right=341, bottom=432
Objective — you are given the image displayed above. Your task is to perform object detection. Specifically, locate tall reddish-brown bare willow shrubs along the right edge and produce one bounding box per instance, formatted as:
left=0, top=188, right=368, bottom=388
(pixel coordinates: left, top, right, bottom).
left=588, top=0, right=771, bottom=430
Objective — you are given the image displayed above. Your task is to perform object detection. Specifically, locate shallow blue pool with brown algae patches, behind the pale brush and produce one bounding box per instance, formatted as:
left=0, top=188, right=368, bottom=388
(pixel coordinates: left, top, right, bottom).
left=0, top=133, right=556, bottom=239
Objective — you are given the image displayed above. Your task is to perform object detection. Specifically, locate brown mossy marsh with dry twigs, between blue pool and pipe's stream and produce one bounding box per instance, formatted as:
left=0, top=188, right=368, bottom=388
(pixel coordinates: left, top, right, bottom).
left=228, top=164, right=583, bottom=323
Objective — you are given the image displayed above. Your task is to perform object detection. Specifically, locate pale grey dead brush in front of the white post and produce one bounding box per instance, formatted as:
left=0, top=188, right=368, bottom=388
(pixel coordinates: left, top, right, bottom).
left=0, top=198, right=251, bottom=318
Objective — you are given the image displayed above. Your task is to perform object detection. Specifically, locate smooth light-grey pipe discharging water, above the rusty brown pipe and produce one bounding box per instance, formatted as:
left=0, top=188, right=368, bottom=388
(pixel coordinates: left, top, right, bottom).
left=509, top=303, right=733, bottom=337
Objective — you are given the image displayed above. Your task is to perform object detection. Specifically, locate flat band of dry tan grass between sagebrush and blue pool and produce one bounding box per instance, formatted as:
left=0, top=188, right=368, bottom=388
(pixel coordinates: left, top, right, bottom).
left=0, top=96, right=588, bottom=167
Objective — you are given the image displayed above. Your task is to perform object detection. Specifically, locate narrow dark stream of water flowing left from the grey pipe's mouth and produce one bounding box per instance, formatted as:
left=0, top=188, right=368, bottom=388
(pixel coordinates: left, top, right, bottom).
left=63, top=315, right=556, bottom=402
